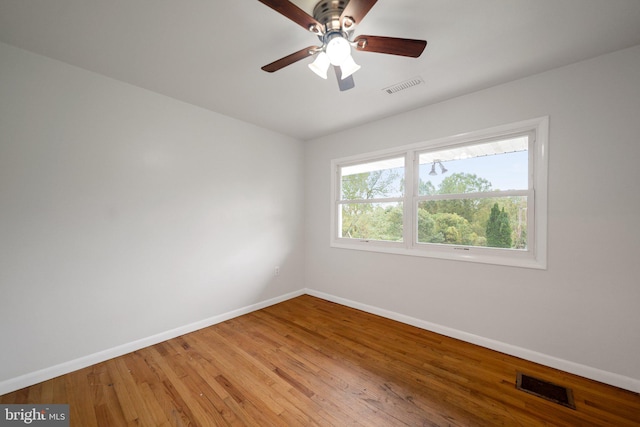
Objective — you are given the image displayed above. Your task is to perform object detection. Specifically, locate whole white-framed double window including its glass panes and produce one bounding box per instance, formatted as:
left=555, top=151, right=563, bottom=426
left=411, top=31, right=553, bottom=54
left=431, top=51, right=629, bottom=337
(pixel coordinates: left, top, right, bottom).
left=331, top=117, right=548, bottom=268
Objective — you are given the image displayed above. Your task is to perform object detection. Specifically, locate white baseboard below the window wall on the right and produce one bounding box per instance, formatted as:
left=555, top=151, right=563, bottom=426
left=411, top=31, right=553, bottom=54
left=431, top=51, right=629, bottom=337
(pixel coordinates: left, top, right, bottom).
left=305, top=289, right=640, bottom=393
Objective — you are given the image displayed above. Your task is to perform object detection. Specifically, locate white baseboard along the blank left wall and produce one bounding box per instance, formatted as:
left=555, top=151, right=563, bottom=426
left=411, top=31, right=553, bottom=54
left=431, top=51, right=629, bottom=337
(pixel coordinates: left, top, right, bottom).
left=0, top=289, right=305, bottom=395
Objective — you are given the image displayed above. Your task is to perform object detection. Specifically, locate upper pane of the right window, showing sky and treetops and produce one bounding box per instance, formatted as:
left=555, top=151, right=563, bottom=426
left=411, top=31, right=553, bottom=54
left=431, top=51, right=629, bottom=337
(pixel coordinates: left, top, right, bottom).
left=418, top=136, right=529, bottom=196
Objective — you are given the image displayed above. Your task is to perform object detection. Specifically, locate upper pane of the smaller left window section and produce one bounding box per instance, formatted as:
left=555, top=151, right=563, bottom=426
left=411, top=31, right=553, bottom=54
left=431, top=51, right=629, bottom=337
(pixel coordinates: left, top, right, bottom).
left=340, top=157, right=404, bottom=200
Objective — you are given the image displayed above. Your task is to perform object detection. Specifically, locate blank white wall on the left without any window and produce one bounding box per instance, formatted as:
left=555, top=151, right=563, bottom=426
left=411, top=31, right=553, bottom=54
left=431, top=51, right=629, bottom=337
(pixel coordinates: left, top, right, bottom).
left=0, top=44, right=303, bottom=394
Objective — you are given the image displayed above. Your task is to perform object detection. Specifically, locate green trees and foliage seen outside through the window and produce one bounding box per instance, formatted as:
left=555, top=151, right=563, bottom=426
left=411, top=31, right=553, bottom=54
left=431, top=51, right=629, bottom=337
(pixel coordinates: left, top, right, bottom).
left=342, top=170, right=527, bottom=249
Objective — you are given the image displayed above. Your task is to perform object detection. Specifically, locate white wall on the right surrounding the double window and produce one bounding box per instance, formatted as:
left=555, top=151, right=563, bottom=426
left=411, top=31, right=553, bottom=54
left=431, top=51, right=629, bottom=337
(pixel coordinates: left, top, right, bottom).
left=305, top=46, right=640, bottom=391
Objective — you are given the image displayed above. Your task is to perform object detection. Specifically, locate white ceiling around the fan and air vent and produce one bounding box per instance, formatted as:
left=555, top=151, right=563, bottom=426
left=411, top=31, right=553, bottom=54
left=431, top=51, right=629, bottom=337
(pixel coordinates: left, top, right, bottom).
left=0, top=0, right=640, bottom=140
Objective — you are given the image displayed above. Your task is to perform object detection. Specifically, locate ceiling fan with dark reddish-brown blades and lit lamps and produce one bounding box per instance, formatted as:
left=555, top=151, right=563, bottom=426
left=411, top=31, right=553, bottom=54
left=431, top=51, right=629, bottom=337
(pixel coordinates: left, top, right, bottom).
left=258, top=0, right=427, bottom=91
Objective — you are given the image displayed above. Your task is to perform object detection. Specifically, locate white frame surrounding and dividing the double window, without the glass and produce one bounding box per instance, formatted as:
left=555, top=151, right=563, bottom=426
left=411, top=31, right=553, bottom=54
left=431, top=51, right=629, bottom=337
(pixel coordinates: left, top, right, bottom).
left=330, top=116, right=549, bottom=269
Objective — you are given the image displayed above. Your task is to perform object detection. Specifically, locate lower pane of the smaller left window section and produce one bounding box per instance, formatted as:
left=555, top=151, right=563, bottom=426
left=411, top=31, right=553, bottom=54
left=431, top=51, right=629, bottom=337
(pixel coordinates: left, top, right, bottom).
left=340, top=203, right=402, bottom=242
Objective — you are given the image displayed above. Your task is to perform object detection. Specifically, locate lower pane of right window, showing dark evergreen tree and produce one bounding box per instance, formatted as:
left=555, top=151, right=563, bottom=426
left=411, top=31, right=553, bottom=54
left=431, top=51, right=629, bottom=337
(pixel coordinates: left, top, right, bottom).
left=418, top=196, right=527, bottom=249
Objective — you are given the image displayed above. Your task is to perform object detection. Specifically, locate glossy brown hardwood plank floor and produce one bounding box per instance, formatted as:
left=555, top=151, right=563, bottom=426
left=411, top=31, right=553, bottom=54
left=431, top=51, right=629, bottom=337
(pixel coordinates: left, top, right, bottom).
left=0, top=295, right=640, bottom=427
